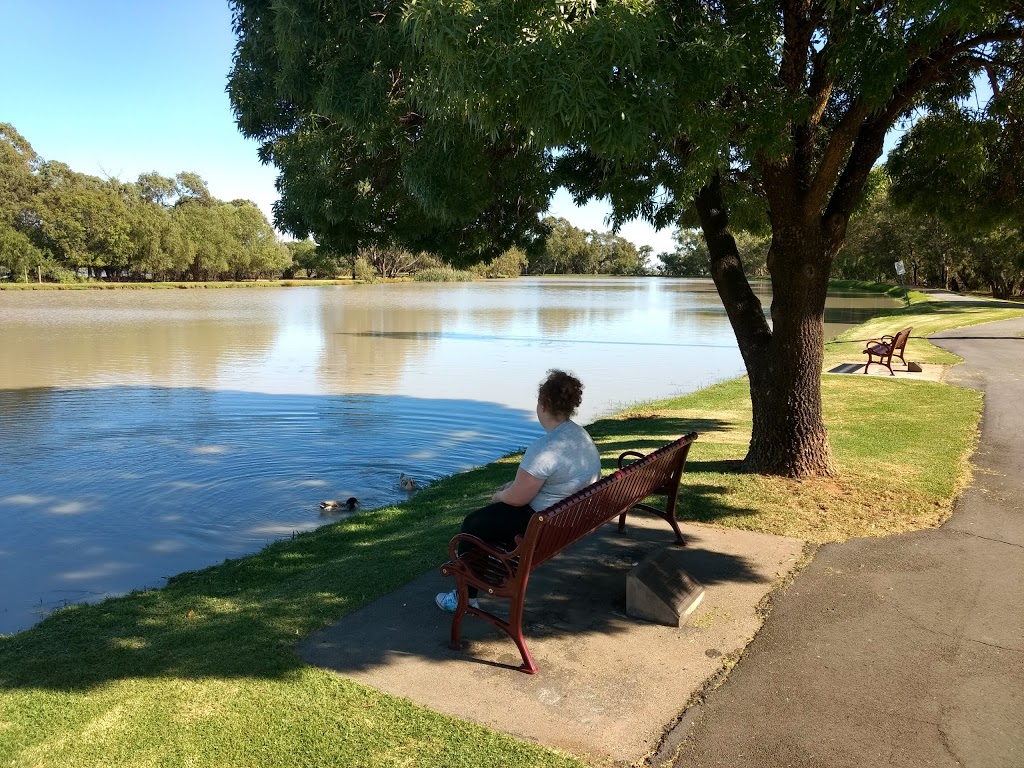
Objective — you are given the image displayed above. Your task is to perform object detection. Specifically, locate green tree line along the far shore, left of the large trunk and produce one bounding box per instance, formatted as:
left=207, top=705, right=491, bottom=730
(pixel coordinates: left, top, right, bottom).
left=0, top=123, right=652, bottom=283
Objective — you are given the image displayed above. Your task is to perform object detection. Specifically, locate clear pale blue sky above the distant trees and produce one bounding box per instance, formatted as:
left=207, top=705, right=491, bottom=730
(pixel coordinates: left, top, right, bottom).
left=6, top=0, right=673, bottom=253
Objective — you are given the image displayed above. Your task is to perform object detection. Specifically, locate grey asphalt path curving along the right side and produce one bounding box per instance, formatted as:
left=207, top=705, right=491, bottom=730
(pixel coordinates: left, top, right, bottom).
left=675, top=313, right=1024, bottom=768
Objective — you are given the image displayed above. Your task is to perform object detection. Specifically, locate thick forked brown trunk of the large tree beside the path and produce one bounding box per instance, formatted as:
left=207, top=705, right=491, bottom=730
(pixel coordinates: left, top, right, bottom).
left=695, top=179, right=836, bottom=477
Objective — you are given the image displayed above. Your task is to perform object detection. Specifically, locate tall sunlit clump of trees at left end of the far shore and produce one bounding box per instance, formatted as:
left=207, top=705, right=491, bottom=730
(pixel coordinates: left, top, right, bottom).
left=0, top=123, right=292, bottom=282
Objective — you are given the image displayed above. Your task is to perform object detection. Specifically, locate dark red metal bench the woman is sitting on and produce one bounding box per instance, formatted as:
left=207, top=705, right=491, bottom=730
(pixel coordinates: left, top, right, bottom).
left=441, top=432, right=697, bottom=675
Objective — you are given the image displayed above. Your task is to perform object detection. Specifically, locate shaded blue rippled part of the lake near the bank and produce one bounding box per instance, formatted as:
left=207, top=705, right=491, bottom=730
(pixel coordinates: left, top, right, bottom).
left=0, top=387, right=540, bottom=632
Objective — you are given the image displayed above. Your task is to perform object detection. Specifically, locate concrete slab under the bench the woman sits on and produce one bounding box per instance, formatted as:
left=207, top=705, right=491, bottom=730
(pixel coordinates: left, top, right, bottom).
left=298, top=516, right=804, bottom=765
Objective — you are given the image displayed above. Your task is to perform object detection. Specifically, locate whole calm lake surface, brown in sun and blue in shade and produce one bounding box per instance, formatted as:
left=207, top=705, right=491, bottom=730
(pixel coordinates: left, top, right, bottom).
left=0, top=278, right=894, bottom=634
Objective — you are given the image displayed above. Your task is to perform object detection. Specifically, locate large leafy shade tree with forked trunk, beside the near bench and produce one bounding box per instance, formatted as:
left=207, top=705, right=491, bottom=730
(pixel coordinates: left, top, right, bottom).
left=228, top=0, right=1024, bottom=476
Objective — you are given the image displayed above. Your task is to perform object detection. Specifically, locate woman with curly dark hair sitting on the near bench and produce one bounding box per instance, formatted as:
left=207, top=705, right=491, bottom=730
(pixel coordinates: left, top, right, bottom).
left=434, top=371, right=601, bottom=613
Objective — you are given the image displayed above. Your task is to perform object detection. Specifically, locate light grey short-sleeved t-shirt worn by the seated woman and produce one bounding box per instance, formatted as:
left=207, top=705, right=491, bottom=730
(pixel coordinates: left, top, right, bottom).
left=519, top=421, right=601, bottom=512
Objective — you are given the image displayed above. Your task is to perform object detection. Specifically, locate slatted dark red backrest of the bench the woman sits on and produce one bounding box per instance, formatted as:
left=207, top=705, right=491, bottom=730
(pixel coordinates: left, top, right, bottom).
left=522, top=432, right=697, bottom=568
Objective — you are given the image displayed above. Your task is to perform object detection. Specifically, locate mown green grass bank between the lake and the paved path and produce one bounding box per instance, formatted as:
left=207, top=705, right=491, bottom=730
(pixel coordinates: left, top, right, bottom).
left=0, top=290, right=1022, bottom=767
